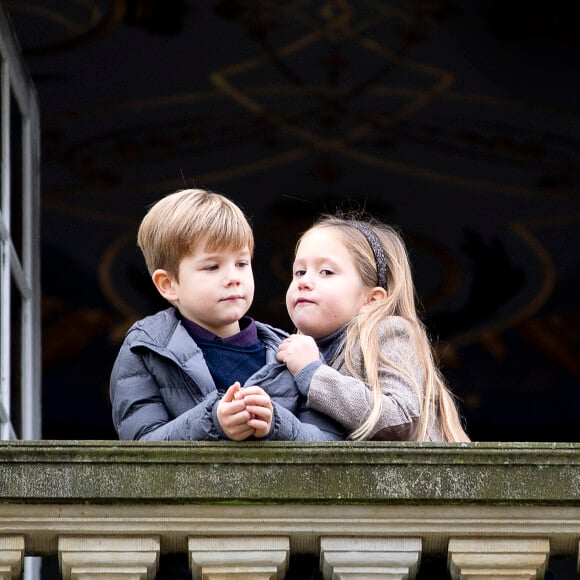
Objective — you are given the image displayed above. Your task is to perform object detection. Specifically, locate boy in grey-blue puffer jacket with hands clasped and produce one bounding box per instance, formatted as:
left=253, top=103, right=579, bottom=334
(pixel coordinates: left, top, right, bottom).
left=110, top=189, right=344, bottom=441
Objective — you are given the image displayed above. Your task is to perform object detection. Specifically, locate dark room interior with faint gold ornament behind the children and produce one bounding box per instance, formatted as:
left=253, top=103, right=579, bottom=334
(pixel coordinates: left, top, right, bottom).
left=4, top=0, right=580, bottom=441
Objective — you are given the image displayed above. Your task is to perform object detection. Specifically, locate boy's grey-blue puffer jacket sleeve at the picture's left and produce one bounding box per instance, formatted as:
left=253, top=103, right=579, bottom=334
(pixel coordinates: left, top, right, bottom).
left=110, top=344, right=220, bottom=441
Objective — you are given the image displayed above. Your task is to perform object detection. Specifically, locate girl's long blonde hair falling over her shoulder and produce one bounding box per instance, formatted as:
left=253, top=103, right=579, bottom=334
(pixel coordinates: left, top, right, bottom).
left=309, top=215, right=469, bottom=441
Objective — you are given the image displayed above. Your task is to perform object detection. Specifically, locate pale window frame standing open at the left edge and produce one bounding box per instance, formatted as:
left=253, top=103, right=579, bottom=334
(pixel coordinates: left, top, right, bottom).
left=0, top=2, right=42, bottom=440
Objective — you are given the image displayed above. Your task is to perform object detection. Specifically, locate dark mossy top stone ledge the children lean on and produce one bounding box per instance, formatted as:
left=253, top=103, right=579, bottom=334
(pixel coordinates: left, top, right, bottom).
left=0, top=441, right=580, bottom=506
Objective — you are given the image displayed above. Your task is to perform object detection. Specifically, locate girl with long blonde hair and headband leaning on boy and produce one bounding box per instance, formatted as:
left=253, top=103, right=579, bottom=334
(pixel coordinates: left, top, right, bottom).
left=278, top=216, right=469, bottom=441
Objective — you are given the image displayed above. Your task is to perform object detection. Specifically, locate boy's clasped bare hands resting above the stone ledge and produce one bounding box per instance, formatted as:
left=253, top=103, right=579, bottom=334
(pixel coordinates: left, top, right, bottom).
left=217, top=382, right=273, bottom=441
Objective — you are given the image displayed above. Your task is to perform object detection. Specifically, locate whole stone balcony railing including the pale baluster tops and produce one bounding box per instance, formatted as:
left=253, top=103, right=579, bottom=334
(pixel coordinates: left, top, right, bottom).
left=0, top=441, right=580, bottom=580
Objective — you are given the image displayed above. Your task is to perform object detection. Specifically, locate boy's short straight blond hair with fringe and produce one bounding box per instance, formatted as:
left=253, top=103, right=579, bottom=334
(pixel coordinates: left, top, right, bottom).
left=137, top=189, right=254, bottom=280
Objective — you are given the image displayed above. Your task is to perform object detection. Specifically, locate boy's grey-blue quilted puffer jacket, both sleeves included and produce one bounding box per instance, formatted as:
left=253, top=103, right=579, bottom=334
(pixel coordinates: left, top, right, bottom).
left=110, top=307, right=345, bottom=441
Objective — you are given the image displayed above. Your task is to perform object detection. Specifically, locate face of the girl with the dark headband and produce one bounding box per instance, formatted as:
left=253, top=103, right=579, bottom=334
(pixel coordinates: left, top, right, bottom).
left=286, top=228, right=369, bottom=339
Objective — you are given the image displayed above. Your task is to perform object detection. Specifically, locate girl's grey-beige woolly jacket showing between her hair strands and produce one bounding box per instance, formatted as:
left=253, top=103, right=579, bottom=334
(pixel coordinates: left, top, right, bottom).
left=307, top=316, right=423, bottom=441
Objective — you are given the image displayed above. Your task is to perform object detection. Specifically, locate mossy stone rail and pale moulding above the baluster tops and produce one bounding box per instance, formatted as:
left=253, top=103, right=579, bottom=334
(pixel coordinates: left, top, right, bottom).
left=0, top=441, right=580, bottom=558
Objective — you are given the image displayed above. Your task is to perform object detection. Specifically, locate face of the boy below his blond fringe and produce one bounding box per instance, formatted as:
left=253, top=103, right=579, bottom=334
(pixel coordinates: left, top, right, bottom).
left=172, top=248, right=254, bottom=338
